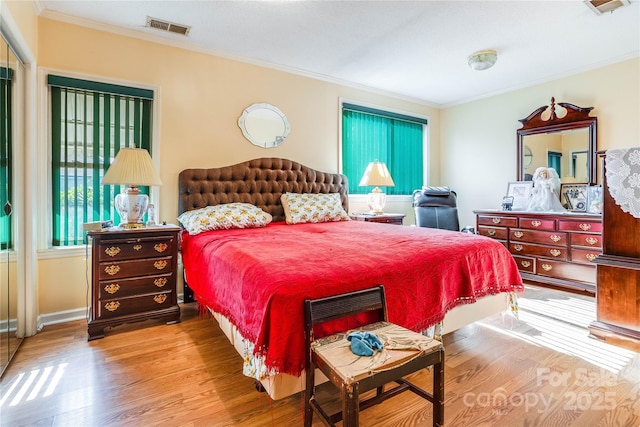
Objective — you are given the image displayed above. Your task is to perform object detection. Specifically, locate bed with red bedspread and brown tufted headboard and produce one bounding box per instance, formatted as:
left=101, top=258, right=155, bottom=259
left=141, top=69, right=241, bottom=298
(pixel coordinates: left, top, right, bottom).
left=178, top=158, right=523, bottom=399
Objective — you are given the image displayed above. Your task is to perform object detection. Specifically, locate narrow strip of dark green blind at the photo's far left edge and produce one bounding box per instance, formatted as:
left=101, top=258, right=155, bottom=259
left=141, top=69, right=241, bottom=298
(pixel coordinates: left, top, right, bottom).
left=0, top=67, right=13, bottom=250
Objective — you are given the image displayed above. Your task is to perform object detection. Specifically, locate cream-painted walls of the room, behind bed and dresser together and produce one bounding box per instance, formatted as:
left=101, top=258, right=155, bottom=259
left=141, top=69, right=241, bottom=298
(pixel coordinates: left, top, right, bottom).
left=6, top=12, right=640, bottom=315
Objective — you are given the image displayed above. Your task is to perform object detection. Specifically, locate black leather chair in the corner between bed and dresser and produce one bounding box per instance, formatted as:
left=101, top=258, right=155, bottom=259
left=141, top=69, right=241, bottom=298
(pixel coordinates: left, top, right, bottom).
left=413, top=187, right=460, bottom=231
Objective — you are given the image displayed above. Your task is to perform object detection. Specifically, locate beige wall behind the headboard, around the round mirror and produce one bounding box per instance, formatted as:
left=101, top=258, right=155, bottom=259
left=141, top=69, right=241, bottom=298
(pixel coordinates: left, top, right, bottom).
left=38, top=18, right=439, bottom=314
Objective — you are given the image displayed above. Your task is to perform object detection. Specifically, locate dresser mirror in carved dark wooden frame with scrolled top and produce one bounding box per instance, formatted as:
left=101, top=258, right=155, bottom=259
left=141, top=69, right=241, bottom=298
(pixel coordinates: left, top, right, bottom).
left=517, top=98, right=598, bottom=185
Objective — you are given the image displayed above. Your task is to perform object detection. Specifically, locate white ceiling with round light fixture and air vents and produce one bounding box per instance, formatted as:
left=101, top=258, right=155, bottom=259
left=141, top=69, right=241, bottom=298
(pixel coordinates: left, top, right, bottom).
left=35, top=0, right=640, bottom=106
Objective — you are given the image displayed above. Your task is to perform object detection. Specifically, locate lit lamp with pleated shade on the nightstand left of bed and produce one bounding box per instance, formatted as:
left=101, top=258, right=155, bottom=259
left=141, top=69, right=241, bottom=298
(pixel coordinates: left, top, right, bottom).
left=102, top=148, right=162, bottom=228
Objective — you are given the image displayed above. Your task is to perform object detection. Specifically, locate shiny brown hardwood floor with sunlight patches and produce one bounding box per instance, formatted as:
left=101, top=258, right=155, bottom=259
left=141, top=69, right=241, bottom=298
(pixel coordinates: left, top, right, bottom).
left=0, top=287, right=640, bottom=427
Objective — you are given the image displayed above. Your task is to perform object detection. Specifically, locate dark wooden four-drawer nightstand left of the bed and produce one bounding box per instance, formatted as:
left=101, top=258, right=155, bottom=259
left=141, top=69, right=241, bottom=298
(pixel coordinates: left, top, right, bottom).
left=87, top=225, right=180, bottom=340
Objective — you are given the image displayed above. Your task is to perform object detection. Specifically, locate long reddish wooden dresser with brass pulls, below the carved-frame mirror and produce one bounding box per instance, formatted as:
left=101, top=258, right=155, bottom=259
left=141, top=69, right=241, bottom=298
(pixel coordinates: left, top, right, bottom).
left=474, top=210, right=602, bottom=295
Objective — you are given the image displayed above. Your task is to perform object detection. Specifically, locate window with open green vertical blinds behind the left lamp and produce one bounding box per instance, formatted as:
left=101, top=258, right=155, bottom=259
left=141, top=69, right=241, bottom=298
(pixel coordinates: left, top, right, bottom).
left=48, top=75, right=153, bottom=246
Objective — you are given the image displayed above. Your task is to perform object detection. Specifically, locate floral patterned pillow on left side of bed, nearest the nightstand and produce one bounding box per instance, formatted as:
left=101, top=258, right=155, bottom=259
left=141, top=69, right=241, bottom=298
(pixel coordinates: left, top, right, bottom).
left=178, top=203, right=273, bottom=235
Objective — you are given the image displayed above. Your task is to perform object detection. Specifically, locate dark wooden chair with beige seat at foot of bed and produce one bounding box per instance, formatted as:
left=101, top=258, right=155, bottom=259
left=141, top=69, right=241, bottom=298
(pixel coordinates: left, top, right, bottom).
left=303, top=286, right=444, bottom=427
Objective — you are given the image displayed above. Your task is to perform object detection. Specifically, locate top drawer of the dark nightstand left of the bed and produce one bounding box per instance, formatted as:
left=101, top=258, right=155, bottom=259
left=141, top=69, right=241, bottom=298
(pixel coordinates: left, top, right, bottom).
left=98, top=237, right=176, bottom=262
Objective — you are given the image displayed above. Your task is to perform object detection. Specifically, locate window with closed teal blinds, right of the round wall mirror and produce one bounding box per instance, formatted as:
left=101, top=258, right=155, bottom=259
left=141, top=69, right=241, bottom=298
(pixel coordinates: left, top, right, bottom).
left=342, top=103, right=427, bottom=194
